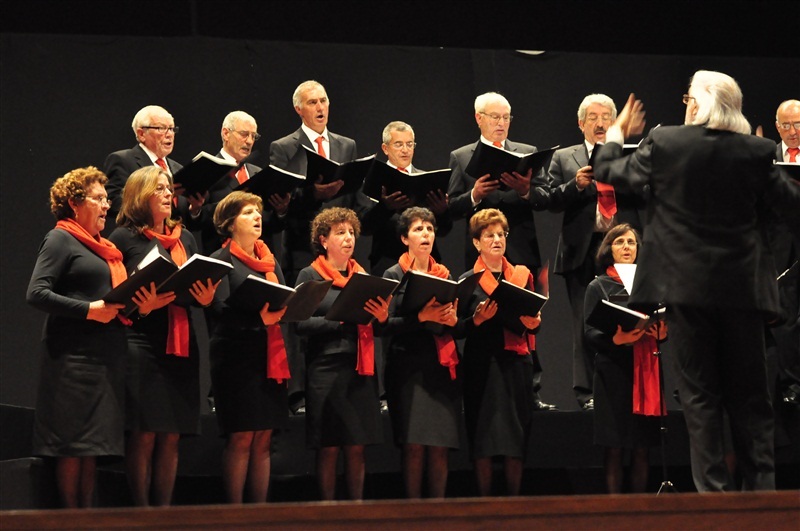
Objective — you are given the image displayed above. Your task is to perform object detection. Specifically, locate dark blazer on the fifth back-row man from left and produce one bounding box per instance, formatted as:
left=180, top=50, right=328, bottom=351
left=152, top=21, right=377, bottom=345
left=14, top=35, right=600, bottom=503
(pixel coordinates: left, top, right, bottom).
left=447, top=140, right=548, bottom=270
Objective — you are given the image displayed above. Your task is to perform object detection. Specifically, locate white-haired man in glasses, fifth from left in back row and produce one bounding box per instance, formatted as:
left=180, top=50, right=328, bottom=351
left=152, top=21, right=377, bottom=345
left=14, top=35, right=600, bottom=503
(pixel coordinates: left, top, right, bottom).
left=447, top=92, right=557, bottom=411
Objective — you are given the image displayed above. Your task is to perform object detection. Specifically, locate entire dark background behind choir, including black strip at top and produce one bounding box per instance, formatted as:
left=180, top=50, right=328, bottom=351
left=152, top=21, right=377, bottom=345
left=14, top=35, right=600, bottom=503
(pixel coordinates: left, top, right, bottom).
left=0, top=1, right=800, bottom=409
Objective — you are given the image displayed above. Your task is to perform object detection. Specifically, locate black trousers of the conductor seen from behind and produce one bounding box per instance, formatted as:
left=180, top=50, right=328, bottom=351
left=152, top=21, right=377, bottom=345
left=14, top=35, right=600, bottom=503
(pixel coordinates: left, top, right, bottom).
left=667, top=305, right=775, bottom=492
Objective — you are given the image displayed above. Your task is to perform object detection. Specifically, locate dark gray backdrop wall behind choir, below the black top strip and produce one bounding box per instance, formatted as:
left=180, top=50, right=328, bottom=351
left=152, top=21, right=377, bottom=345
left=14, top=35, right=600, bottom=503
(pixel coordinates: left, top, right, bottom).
left=0, top=34, right=800, bottom=409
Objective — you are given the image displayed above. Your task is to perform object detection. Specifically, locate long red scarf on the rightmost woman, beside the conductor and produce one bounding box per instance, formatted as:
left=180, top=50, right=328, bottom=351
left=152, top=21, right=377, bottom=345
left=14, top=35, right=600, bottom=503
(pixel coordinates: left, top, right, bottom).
left=606, top=265, right=667, bottom=416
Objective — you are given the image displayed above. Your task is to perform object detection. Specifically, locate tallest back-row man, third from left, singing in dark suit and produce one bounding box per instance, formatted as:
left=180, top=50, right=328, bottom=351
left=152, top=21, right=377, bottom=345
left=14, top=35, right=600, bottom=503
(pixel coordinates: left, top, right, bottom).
left=269, top=80, right=371, bottom=413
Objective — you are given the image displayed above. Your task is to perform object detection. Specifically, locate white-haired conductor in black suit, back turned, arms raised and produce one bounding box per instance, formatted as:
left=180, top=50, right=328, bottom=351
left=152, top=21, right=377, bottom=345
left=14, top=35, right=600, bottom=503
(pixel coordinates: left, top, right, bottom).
left=594, top=70, right=800, bottom=492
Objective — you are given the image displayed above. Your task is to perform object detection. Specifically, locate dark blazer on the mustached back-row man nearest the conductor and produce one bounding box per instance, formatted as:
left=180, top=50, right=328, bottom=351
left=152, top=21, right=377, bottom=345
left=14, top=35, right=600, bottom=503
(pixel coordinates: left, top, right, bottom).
left=547, top=143, right=644, bottom=273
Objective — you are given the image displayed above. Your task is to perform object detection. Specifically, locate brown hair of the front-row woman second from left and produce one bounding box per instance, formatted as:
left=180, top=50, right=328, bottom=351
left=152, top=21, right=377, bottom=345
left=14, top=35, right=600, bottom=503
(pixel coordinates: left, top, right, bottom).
left=117, top=166, right=178, bottom=233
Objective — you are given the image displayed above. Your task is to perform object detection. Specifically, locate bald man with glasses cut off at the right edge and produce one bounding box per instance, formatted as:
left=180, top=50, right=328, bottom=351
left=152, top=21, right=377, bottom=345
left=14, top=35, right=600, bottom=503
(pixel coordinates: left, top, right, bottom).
left=767, top=100, right=800, bottom=414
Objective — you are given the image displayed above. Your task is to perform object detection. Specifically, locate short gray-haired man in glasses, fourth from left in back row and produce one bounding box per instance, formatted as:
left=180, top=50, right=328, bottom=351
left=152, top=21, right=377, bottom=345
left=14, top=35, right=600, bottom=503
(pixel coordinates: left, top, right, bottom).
left=361, top=121, right=453, bottom=276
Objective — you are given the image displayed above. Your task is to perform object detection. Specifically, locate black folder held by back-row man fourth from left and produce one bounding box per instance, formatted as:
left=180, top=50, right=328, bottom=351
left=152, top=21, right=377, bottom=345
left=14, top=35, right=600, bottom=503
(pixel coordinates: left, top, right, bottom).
left=364, top=160, right=452, bottom=206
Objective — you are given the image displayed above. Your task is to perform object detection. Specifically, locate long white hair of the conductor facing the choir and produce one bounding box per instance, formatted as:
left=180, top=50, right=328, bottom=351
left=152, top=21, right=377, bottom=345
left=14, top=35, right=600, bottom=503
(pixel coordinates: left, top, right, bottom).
left=686, top=70, right=752, bottom=135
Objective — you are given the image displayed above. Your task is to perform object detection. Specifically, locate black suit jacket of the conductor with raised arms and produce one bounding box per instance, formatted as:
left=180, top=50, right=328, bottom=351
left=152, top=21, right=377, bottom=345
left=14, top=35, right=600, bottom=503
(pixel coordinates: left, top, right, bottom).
left=594, top=126, right=800, bottom=315
